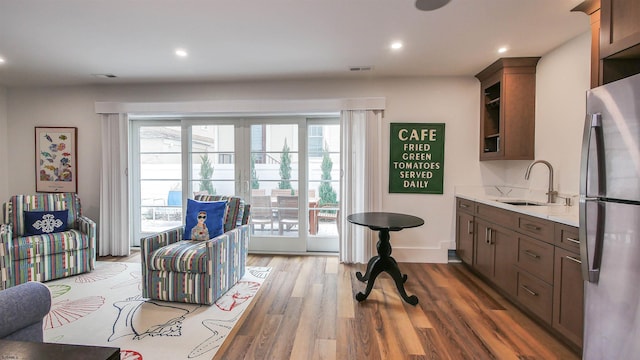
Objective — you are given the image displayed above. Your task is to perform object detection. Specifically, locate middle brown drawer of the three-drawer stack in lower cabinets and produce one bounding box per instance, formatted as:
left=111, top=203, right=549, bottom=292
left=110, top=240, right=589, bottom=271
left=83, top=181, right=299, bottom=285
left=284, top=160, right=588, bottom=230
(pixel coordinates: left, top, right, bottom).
left=517, top=236, right=554, bottom=284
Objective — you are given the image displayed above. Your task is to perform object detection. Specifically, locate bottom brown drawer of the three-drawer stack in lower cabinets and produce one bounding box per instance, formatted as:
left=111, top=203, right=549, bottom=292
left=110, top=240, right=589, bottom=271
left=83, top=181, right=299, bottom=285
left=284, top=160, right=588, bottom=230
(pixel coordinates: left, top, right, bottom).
left=516, top=271, right=553, bottom=324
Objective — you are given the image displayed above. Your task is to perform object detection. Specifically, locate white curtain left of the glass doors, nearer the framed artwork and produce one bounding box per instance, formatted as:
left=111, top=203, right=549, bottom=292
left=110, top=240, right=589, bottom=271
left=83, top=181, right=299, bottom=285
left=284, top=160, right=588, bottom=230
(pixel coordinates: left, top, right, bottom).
left=98, top=114, right=130, bottom=256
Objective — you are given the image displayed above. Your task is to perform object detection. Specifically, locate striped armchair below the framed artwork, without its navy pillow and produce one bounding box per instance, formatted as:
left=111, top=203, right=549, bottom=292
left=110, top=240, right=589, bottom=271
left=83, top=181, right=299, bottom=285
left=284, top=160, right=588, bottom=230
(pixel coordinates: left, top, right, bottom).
left=0, top=193, right=96, bottom=289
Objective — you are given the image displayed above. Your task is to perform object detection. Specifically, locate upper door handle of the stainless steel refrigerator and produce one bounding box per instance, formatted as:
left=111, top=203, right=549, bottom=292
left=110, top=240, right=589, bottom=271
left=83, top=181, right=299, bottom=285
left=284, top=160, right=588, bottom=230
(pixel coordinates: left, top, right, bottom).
left=580, top=113, right=606, bottom=196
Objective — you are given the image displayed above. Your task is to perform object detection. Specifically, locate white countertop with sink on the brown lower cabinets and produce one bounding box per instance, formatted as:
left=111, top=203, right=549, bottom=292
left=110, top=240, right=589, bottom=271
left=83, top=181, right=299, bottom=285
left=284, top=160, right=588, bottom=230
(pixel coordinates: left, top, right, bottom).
left=455, top=186, right=579, bottom=227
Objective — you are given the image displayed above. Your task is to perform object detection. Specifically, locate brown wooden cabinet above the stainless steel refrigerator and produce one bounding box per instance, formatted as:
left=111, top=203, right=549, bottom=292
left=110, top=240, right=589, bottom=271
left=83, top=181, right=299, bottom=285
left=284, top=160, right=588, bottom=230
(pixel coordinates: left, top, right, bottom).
left=573, top=0, right=640, bottom=88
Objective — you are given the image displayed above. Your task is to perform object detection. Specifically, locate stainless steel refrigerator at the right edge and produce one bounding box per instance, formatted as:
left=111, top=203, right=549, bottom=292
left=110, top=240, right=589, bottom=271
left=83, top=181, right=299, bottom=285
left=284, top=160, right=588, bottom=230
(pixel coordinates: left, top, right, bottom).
left=580, top=71, right=640, bottom=360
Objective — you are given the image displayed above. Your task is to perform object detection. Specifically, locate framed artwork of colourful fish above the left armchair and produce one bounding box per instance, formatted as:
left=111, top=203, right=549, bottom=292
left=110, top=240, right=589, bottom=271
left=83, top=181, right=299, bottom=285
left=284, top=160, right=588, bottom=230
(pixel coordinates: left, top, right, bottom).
left=35, top=127, right=78, bottom=193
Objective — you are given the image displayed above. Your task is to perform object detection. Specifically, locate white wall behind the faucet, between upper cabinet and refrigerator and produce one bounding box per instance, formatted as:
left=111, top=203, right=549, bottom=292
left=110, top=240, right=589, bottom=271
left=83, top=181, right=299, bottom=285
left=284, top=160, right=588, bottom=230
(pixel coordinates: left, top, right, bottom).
left=483, top=33, right=591, bottom=194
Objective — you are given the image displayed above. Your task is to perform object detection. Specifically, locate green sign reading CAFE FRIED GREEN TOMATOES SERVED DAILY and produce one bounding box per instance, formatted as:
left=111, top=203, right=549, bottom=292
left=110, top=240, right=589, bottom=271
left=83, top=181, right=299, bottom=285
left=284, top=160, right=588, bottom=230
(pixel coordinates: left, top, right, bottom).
left=389, top=123, right=444, bottom=194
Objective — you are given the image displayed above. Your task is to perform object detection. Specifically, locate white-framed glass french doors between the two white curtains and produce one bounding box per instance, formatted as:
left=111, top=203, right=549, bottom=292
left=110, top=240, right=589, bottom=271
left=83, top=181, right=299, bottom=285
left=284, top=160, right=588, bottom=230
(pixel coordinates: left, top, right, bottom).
left=132, top=117, right=340, bottom=253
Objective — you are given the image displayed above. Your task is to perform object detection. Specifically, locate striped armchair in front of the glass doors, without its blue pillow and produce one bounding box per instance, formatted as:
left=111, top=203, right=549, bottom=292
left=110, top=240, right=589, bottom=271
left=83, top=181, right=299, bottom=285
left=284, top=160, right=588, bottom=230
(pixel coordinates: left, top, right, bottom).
left=140, top=195, right=251, bottom=305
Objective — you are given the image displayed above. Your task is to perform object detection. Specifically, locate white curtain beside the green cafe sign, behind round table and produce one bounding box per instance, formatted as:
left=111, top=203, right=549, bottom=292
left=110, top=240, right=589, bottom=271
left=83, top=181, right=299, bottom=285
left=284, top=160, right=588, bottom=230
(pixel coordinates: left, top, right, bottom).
left=338, top=110, right=383, bottom=263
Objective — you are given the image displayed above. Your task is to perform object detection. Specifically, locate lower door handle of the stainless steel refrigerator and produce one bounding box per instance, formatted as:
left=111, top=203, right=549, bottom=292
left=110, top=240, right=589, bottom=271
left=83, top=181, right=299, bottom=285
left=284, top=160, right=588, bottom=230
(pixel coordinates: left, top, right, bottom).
left=580, top=198, right=605, bottom=283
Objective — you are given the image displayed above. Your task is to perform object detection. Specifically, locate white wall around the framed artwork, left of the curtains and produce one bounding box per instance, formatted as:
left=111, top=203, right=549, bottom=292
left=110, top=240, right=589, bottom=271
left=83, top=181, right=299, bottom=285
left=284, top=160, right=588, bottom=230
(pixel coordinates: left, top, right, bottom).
left=7, top=87, right=100, bottom=220
